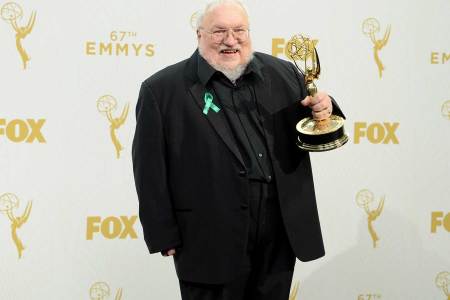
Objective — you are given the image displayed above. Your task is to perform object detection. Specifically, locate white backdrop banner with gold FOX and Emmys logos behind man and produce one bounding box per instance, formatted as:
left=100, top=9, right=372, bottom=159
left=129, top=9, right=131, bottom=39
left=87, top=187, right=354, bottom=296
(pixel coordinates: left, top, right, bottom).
left=0, top=0, right=450, bottom=300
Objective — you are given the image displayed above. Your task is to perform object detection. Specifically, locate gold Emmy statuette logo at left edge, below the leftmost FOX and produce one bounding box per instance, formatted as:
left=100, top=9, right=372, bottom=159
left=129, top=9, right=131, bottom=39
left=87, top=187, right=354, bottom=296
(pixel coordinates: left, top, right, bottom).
left=0, top=193, right=32, bottom=259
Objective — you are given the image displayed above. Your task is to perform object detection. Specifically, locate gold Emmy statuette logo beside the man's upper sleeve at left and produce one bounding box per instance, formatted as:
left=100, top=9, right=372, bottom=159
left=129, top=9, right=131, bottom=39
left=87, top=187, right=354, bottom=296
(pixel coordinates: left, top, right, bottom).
left=97, top=95, right=130, bottom=159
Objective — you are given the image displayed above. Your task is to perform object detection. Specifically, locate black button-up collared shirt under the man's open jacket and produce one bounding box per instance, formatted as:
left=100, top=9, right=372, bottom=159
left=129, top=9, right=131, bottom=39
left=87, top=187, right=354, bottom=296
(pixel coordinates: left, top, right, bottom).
left=198, top=56, right=273, bottom=182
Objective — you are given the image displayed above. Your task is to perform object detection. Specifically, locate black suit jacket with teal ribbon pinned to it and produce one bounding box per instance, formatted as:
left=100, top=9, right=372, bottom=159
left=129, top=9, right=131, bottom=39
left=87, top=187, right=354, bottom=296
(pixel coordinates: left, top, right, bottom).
left=133, top=51, right=342, bottom=283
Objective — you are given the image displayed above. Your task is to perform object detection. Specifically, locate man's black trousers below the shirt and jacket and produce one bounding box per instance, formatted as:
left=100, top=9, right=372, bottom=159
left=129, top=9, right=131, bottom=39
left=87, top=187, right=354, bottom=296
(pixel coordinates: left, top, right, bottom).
left=180, top=181, right=295, bottom=300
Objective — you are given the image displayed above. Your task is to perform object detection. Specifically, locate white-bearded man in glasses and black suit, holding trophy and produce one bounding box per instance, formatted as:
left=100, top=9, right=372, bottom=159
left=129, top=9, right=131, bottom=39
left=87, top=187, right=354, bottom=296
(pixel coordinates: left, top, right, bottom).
left=133, top=0, right=342, bottom=300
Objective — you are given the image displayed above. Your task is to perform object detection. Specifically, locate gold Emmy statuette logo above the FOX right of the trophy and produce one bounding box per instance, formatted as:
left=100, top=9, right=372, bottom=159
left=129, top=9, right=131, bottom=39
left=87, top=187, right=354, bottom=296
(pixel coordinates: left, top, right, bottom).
left=362, top=18, right=391, bottom=78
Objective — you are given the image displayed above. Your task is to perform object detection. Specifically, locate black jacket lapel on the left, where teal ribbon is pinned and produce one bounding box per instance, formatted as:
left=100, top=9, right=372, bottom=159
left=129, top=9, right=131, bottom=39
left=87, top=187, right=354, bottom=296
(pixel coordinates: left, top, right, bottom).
left=190, top=82, right=245, bottom=167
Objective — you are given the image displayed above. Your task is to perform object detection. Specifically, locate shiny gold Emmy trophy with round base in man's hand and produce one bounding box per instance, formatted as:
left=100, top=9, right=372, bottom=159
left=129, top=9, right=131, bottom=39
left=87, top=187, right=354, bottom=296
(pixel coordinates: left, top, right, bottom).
left=286, top=35, right=348, bottom=152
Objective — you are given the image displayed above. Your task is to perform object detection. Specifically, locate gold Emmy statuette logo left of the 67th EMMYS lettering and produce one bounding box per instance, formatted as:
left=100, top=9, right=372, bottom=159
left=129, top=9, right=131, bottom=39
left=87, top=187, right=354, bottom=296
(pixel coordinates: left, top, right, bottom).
left=0, top=2, right=36, bottom=70
